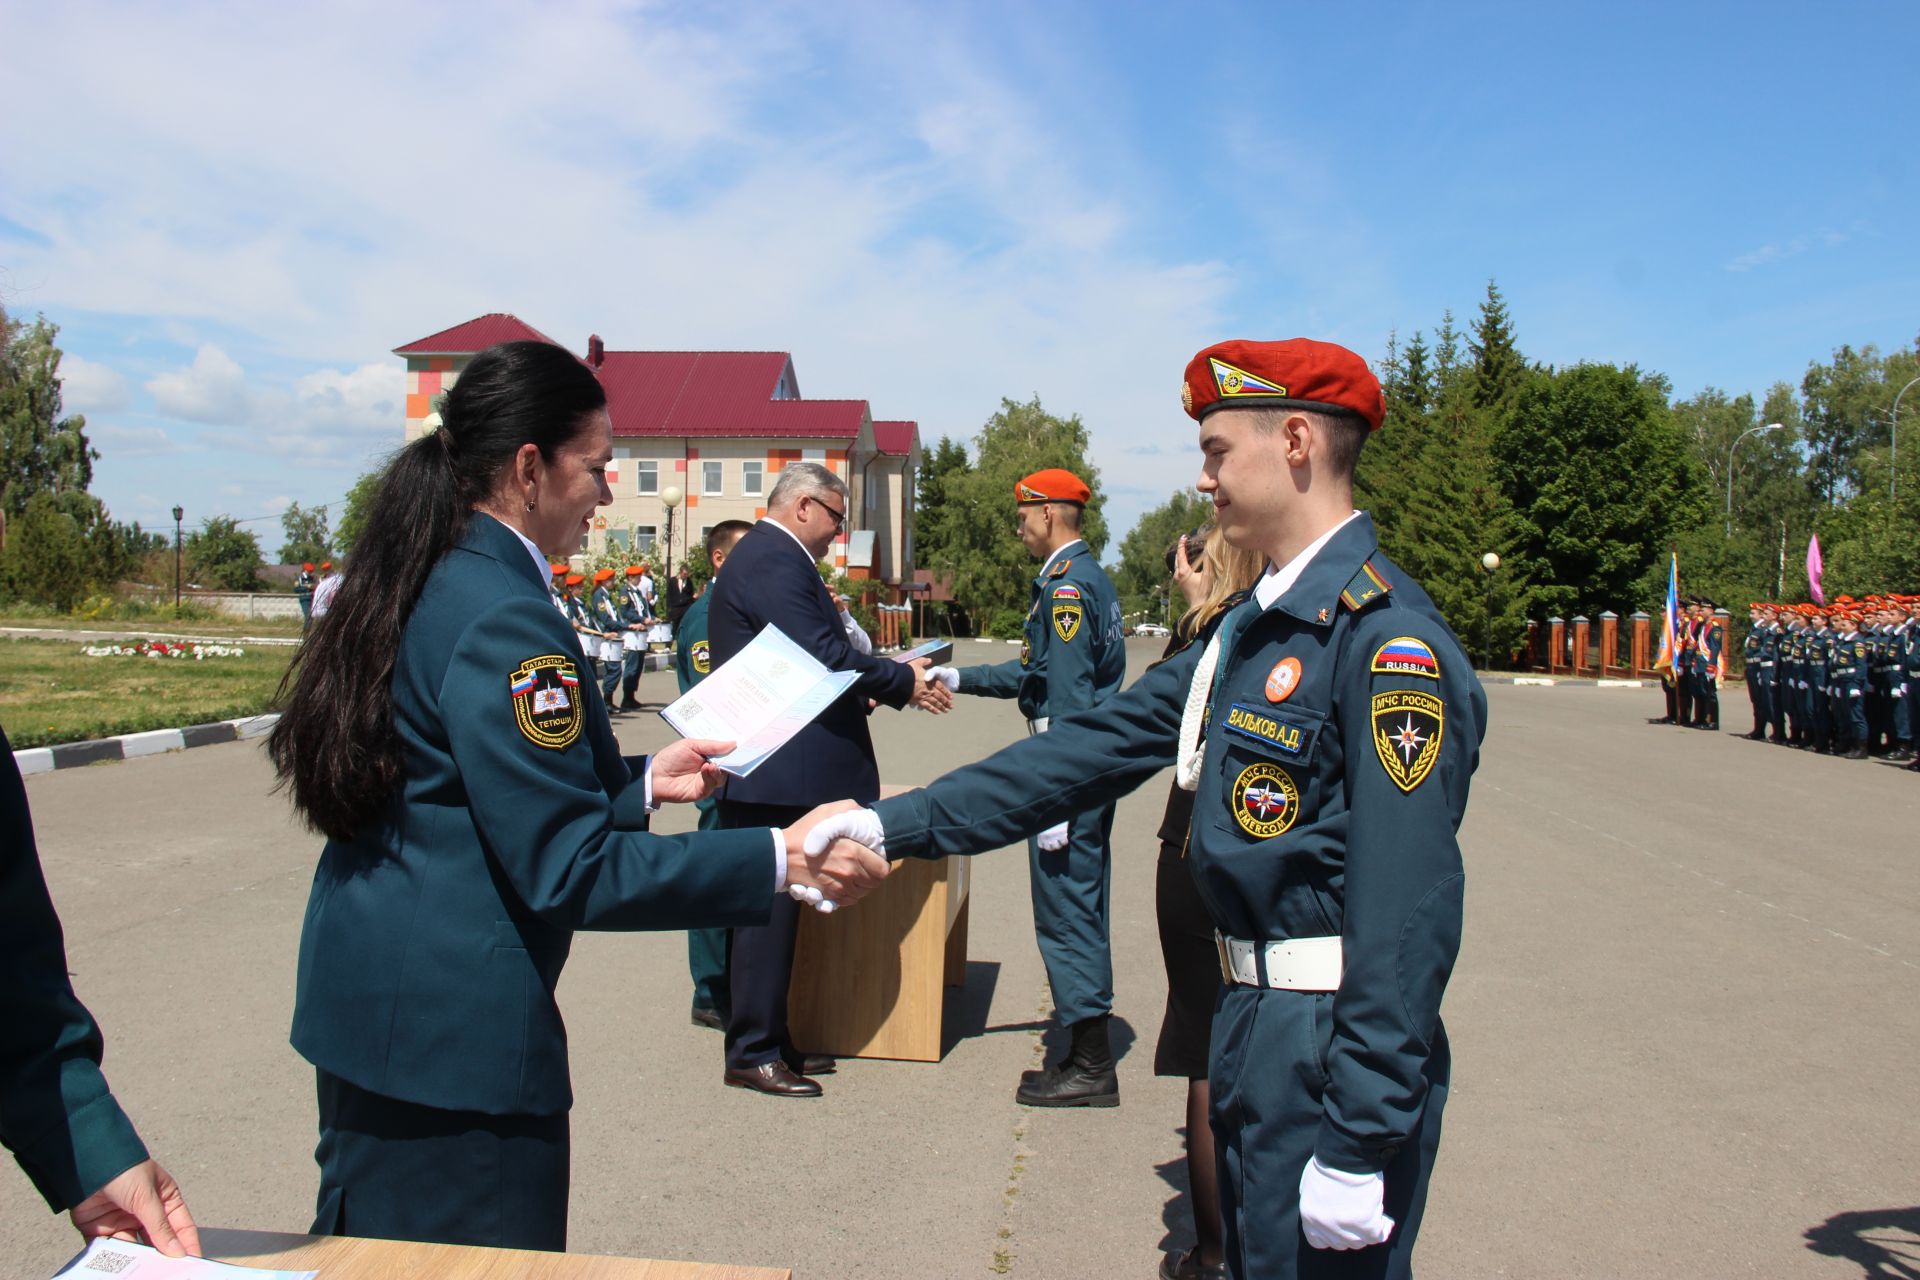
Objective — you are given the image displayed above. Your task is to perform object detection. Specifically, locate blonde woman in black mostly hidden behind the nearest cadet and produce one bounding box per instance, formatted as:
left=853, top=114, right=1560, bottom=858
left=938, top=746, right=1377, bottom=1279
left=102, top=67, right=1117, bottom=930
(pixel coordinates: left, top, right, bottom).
left=1154, top=522, right=1267, bottom=1280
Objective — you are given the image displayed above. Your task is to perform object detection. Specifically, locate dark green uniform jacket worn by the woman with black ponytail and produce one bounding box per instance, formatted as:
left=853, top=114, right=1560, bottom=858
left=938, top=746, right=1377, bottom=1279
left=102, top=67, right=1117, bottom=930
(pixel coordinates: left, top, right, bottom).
left=294, top=514, right=774, bottom=1115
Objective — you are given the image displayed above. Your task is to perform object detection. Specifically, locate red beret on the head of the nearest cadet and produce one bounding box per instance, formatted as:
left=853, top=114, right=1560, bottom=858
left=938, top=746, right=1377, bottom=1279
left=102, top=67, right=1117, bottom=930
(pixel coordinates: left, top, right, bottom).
left=1181, top=338, right=1386, bottom=430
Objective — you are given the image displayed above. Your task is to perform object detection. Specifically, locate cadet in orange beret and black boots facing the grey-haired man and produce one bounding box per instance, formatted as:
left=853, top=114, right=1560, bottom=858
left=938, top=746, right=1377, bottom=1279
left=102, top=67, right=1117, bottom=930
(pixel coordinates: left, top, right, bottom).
left=935, top=466, right=1127, bottom=1107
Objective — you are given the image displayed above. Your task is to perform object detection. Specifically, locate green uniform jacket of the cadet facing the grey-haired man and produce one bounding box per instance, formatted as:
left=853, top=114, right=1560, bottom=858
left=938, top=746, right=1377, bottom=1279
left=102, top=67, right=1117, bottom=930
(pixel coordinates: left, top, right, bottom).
left=960, top=539, right=1127, bottom=720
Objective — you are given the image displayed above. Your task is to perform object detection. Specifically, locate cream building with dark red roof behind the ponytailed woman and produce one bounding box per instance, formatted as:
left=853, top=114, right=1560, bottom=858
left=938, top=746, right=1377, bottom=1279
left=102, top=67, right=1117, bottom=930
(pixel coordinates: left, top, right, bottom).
left=394, top=313, right=920, bottom=599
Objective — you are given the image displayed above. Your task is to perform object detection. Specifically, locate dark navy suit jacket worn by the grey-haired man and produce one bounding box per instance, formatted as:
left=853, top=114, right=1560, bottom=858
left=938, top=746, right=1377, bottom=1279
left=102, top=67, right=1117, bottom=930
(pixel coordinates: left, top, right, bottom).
left=707, top=520, right=914, bottom=806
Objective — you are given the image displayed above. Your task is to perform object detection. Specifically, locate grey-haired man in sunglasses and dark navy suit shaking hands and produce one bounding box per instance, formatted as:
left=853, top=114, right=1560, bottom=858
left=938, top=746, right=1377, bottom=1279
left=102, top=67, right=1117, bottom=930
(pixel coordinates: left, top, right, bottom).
left=707, top=462, right=952, bottom=1098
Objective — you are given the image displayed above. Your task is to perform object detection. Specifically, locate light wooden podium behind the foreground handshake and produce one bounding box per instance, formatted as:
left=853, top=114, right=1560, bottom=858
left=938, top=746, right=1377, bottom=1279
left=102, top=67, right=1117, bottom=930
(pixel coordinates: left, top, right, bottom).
left=787, top=858, right=972, bottom=1063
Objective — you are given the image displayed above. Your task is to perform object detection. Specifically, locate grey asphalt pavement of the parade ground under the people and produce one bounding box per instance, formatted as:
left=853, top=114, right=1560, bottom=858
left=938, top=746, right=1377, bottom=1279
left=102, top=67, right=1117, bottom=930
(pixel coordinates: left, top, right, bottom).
left=0, top=641, right=1920, bottom=1280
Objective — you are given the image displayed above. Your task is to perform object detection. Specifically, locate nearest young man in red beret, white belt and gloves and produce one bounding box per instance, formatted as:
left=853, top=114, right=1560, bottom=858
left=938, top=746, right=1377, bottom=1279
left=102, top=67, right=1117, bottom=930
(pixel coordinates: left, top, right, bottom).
left=808, top=338, right=1486, bottom=1280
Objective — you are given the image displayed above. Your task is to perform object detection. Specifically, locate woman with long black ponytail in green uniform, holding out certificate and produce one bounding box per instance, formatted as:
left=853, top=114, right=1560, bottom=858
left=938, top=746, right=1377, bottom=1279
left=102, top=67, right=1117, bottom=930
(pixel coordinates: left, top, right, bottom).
left=269, top=342, right=885, bottom=1249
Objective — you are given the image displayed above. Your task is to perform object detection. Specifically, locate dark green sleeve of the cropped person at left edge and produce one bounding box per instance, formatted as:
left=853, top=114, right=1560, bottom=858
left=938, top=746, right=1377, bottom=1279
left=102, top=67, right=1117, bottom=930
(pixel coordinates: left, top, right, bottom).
left=0, top=733, right=146, bottom=1211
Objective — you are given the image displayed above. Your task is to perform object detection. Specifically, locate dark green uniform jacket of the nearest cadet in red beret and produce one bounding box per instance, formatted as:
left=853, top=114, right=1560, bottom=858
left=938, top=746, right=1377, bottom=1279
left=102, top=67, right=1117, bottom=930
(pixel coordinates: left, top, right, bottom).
left=874, top=516, right=1486, bottom=1173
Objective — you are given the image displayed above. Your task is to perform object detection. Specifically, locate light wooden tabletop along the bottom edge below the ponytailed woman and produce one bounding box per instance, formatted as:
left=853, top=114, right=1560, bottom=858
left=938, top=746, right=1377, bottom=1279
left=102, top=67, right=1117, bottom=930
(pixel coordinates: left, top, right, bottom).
left=200, top=1226, right=793, bottom=1280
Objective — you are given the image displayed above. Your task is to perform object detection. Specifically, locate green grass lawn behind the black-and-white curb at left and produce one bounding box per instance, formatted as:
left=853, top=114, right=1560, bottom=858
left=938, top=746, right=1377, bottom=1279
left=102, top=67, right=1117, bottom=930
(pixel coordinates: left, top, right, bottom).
left=0, top=637, right=298, bottom=750
